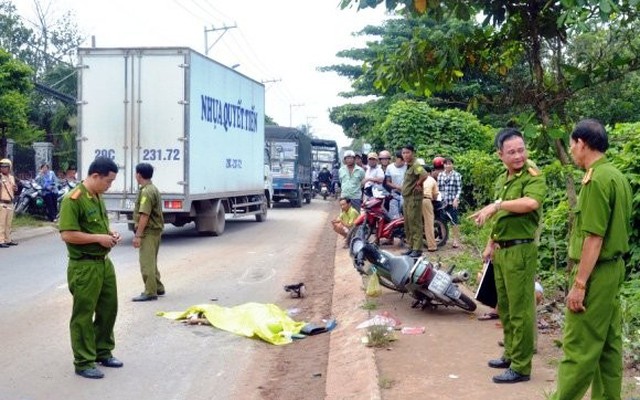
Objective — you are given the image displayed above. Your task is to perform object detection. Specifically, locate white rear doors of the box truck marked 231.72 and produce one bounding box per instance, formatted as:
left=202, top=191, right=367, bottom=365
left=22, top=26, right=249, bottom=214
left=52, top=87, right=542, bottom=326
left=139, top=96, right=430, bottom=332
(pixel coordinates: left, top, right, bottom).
left=78, top=49, right=186, bottom=210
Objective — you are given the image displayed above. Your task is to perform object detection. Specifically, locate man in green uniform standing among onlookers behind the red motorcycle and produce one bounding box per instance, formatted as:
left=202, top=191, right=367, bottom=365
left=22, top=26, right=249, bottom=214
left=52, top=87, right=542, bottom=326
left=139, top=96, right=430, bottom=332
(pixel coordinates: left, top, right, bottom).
left=402, top=144, right=429, bottom=257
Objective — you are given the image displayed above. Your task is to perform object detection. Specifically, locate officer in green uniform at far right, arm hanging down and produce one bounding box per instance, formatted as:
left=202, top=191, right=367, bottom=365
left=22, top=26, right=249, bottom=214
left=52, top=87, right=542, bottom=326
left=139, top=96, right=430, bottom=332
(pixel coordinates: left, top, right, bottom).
left=551, top=119, right=632, bottom=400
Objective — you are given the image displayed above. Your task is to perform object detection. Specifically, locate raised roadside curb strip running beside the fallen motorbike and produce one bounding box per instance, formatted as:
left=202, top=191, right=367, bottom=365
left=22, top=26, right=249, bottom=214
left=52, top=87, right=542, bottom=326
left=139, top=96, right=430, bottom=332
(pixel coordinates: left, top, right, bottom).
left=325, top=237, right=381, bottom=400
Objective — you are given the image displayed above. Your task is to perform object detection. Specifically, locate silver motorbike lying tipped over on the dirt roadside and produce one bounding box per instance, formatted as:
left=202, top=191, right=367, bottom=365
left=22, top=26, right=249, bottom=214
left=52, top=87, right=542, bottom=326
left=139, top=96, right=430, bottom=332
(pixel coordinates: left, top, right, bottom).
left=349, top=230, right=477, bottom=311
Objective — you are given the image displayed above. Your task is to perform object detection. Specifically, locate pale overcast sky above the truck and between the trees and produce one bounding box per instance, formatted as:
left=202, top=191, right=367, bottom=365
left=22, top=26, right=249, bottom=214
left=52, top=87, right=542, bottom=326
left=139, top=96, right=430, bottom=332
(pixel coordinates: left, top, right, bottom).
left=14, top=0, right=385, bottom=146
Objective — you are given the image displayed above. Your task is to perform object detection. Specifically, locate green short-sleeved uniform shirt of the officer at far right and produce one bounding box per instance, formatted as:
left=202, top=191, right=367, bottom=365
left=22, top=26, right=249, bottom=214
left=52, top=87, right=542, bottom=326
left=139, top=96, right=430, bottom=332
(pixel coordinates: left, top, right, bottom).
left=569, top=157, right=632, bottom=261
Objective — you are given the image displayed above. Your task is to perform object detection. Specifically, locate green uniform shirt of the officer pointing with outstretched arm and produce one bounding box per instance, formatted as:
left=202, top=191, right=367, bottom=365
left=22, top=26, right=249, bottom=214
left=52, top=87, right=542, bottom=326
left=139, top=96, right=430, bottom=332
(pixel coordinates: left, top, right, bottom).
left=491, top=166, right=547, bottom=241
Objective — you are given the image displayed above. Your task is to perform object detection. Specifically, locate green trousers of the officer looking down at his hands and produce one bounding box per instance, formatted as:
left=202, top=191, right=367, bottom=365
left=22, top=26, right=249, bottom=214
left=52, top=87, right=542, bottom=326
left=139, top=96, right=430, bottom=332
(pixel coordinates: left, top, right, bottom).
left=67, top=258, right=118, bottom=371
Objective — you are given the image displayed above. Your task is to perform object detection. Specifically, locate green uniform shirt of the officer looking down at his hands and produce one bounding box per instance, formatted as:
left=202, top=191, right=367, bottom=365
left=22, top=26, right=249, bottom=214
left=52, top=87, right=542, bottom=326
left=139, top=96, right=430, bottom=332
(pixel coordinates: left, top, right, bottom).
left=58, top=183, right=110, bottom=259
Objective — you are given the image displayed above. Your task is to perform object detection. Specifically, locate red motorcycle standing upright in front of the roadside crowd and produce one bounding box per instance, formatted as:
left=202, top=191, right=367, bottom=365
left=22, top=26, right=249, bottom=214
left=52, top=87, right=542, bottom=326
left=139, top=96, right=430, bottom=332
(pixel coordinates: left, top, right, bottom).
left=347, top=197, right=405, bottom=245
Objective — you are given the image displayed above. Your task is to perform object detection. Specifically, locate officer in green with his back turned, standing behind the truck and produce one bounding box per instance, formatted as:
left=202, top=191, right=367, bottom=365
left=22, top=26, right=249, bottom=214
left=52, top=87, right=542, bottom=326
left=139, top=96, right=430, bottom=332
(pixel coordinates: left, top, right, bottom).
left=132, top=163, right=164, bottom=301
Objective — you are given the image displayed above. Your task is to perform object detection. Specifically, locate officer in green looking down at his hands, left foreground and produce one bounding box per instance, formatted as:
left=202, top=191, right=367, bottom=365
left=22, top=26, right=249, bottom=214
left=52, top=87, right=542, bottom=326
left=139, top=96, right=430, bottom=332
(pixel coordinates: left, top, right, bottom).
left=58, top=158, right=122, bottom=379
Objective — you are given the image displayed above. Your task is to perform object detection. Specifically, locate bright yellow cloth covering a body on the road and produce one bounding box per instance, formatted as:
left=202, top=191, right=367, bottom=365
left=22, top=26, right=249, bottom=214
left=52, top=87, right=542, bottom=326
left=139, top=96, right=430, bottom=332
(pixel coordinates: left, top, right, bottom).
left=157, top=303, right=306, bottom=345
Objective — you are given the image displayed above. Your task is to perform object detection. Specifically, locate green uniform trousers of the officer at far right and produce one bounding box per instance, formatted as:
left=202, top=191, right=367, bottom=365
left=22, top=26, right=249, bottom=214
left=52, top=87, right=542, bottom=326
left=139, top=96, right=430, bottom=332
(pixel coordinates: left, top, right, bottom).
left=551, top=259, right=624, bottom=400
